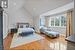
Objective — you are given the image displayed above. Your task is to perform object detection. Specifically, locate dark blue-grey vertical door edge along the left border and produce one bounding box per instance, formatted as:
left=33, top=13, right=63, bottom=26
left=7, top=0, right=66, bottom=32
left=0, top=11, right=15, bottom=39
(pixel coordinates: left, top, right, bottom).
left=0, top=8, right=3, bottom=50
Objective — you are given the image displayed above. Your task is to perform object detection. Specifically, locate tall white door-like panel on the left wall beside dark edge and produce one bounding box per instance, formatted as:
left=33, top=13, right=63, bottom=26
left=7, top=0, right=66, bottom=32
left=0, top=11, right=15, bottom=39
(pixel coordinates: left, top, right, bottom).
left=3, top=12, right=9, bottom=39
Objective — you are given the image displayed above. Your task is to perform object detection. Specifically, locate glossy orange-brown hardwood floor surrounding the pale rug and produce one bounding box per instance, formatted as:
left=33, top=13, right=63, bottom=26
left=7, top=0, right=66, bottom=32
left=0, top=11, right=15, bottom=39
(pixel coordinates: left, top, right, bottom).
left=4, top=34, right=67, bottom=50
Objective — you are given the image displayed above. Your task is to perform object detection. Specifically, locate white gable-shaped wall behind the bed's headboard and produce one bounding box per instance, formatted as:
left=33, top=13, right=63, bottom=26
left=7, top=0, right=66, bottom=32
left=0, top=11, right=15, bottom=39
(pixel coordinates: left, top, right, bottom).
left=9, top=9, right=33, bottom=27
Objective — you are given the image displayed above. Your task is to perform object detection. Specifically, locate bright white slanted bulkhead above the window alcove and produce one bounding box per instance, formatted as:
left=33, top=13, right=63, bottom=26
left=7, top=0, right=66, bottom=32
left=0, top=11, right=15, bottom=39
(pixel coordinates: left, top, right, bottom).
left=40, top=1, right=74, bottom=16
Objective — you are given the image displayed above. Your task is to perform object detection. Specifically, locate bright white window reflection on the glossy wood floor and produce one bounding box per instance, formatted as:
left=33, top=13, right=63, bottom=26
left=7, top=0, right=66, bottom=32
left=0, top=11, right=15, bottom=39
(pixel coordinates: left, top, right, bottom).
left=49, top=42, right=67, bottom=50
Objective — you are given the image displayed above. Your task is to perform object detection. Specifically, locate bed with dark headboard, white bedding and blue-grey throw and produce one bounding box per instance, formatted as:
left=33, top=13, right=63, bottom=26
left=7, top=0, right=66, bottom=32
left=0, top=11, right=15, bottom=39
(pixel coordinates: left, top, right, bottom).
left=17, top=23, right=34, bottom=36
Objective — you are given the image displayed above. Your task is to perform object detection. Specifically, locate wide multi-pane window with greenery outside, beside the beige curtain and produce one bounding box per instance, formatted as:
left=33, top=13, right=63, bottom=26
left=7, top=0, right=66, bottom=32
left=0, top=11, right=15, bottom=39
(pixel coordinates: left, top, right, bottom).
left=49, top=14, right=66, bottom=27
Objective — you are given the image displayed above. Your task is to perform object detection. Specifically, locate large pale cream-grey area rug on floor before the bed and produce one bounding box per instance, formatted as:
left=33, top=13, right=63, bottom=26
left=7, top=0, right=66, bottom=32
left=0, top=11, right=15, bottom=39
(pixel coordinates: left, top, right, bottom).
left=10, top=34, right=44, bottom=48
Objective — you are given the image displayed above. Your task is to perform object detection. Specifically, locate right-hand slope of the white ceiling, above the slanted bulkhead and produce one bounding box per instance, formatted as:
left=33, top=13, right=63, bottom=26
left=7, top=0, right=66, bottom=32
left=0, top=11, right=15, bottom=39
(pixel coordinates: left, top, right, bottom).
left=24, top=0, right=73, bottom=16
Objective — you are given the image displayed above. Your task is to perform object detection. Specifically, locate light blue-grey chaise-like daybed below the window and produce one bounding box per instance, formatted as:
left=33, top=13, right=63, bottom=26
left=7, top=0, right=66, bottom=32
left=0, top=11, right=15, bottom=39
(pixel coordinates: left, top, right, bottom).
left=40, top=27, right=59, bottom=38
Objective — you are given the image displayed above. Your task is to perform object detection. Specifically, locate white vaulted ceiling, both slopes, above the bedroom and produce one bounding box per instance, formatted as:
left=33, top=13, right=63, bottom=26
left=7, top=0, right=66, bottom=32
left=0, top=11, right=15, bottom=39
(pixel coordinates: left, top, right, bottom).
left=8, top=0, right=73, bottom=16
